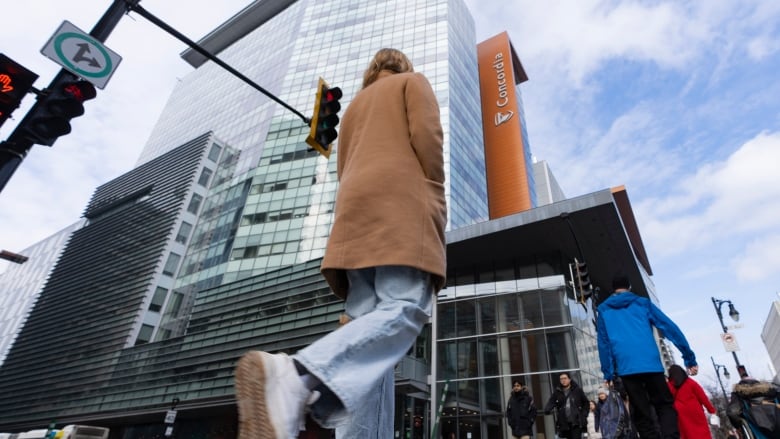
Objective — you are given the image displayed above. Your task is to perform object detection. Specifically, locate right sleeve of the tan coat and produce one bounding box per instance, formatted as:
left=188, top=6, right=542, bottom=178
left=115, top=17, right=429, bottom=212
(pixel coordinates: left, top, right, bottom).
left=405, top=73, right=444, bottom=183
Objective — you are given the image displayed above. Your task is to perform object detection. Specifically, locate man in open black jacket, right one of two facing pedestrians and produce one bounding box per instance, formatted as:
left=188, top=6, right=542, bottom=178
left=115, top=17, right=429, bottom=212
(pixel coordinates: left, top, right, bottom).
left=544, top=372, right=590, bottom=439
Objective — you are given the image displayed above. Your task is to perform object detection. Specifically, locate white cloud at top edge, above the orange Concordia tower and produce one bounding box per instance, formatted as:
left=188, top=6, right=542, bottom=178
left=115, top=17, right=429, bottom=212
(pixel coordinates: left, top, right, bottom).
left=467, top=0, right=711, bottom=86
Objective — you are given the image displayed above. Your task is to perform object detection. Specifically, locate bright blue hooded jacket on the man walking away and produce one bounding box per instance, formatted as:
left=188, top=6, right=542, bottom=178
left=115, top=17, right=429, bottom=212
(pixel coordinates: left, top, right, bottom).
left=596, top=291, right=696, bottom=380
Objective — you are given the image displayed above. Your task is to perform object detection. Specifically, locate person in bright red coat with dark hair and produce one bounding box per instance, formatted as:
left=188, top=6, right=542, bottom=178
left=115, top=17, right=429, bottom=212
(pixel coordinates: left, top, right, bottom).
left=668, top=364, right=715, bottom=439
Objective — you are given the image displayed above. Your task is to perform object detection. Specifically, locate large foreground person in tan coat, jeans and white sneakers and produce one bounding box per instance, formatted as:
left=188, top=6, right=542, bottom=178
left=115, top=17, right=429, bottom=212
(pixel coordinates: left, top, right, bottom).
left=236, top=49, right=447, bottom=439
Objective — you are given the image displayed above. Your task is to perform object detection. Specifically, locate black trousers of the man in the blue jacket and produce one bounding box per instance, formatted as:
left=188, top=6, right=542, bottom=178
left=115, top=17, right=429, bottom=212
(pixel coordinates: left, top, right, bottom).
left=620, top=372, right=680, bottom=439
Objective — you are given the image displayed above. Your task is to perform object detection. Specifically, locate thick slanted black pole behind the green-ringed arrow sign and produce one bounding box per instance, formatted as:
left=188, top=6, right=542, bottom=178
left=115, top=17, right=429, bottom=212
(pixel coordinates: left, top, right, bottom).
left=0, top=0, right=132, bottom=192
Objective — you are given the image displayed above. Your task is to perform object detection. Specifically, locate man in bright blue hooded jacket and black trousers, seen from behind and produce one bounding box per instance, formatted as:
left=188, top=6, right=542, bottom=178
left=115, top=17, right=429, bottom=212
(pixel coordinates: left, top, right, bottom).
left=596, top=276, right=699, bottom=439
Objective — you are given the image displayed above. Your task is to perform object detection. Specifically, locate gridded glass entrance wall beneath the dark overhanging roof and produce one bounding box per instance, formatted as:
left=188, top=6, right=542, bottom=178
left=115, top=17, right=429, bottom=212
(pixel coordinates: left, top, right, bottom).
left=432, top=255, right=599, bottom=439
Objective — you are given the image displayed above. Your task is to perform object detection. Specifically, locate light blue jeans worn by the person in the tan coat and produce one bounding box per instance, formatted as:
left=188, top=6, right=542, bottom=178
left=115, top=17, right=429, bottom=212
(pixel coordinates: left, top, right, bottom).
left=293, top=266, right=434, bottom=439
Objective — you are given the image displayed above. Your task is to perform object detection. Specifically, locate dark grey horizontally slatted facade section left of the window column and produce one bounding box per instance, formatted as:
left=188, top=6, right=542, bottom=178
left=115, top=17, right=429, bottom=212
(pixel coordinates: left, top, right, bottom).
left=0, top=135, right=210, bottom=425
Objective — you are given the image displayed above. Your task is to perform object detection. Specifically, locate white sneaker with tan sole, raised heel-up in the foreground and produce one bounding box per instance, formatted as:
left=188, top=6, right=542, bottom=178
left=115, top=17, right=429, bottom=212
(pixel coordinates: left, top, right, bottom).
left=236, top=351, right=319, bottom=439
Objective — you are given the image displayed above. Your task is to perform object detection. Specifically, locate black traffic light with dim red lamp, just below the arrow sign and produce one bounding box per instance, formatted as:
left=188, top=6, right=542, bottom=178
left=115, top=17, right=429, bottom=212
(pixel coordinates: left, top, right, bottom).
left=23, top=74, right=97, bottom=146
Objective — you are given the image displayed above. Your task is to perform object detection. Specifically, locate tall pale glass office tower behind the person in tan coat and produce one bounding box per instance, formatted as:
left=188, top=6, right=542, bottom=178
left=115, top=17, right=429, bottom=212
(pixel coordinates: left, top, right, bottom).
left=139, top=0, right=488, bottom=340
